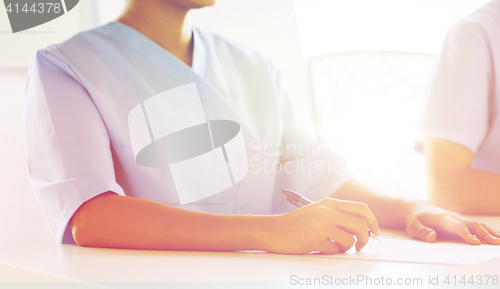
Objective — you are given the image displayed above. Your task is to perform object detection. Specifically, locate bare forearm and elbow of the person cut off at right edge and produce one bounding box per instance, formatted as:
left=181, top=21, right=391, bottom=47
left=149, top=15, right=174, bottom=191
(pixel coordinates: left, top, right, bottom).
left=428, top=168, right=500, bottom=214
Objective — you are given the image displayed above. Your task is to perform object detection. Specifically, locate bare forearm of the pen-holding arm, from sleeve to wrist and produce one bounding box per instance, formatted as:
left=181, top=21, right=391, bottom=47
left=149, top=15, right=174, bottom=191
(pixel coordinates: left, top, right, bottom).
left=70, top=193, right=272, bottom=251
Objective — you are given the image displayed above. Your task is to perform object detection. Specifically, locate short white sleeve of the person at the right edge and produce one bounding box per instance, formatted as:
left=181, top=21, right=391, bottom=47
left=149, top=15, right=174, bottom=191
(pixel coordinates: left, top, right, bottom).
left=422, top=18, right=492, bottom=153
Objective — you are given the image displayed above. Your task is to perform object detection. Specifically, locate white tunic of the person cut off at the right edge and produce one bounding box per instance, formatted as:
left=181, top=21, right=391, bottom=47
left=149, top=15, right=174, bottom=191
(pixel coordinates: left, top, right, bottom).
left=423, top=0, right=500, bottom=173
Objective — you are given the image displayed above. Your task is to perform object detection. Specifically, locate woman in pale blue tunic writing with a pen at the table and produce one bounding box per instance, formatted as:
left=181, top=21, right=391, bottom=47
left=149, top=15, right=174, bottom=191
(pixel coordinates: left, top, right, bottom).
left=25, top=0, right=500, bottom=254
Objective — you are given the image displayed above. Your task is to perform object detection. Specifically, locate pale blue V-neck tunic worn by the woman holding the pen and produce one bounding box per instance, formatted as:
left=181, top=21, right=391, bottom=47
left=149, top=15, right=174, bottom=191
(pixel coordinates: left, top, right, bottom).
left=25, top=22, right=350, bottom=243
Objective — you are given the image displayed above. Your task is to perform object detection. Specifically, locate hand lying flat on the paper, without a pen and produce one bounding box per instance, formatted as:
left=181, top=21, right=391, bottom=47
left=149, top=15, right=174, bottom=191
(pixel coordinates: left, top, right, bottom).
left=406, top=202, right=500, bottom=245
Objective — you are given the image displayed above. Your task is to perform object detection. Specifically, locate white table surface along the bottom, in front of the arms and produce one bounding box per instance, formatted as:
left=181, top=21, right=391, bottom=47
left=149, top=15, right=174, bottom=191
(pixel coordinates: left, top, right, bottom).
left=0, top=217, right=500, bottom=288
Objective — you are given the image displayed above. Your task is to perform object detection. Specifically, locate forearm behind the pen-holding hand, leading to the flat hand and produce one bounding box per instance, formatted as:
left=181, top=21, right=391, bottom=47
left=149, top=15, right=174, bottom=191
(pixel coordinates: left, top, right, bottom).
left=331, top=181, right=413, bottom=230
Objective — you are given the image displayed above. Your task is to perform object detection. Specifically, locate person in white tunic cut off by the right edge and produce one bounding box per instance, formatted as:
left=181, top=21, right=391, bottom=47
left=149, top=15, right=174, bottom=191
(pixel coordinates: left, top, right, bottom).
left=423, top=0, right=500, bottom=214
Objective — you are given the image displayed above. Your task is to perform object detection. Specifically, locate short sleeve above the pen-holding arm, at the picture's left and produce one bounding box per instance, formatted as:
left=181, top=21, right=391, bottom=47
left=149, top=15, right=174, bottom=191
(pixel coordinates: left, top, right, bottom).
left=24, top=46, right=125, bottom=243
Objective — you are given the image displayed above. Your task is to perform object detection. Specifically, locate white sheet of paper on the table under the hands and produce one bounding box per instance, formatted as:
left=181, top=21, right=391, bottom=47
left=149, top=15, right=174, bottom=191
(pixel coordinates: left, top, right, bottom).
left=322, top=239, right=500, bottom=265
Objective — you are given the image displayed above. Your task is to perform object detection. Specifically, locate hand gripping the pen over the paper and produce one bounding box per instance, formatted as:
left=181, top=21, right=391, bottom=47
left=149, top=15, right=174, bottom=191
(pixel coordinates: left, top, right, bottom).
left=266, top=198, right=380, bottom=254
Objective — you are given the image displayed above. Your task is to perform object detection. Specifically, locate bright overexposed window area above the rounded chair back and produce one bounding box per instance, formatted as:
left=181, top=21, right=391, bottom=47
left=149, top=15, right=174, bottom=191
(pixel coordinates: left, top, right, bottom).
left=294, top=0, right=488, bottom=57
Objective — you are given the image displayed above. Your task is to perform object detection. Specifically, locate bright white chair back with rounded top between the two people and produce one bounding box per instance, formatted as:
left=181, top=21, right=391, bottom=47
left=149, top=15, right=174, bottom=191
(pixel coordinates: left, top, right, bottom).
left=311, top=52, right=434, bottom=198
